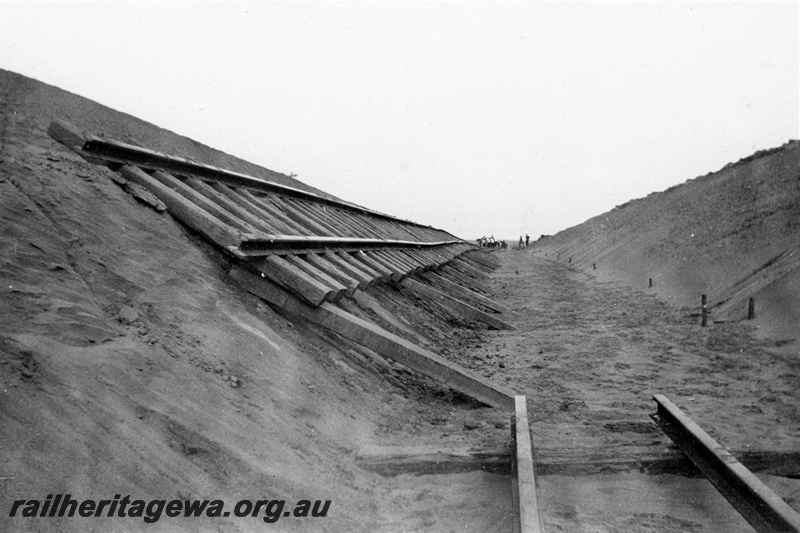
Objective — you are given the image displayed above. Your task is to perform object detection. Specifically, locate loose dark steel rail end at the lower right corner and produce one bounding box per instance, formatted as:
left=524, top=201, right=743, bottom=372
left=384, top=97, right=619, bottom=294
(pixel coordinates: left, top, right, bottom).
left=652, top=394, right=800, bottom=533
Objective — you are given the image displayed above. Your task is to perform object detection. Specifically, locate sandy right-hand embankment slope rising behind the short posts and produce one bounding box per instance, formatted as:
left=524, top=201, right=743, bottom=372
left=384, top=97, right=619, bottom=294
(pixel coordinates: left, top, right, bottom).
left=535, top=141, right=800, bottom=340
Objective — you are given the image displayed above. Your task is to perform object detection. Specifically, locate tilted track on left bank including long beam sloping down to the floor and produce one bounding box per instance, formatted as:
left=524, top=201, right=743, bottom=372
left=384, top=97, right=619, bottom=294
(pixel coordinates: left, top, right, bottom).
left=48, top=121, right=514, bottom=410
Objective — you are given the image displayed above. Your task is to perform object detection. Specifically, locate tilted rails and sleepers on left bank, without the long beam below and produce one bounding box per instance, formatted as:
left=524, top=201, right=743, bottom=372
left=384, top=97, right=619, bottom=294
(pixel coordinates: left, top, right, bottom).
left=48, top=121, right=482, bottom=306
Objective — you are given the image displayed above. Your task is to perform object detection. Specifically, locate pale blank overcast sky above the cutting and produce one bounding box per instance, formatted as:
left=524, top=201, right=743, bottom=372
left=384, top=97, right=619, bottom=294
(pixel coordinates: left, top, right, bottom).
left=0, top=2, right=800, bottom=239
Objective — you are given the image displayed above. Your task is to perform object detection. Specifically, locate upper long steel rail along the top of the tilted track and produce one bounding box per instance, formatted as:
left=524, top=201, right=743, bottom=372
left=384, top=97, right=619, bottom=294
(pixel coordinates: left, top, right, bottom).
left=79, top=135, right=460, bottom=240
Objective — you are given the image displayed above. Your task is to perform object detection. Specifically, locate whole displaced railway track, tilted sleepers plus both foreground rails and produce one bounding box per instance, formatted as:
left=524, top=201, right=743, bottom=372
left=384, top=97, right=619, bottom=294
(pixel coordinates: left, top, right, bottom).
left=48, top=121, right=800, bottom=533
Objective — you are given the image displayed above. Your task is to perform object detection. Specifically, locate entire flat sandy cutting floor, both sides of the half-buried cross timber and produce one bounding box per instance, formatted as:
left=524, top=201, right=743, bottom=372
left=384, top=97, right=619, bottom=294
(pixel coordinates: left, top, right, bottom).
left=376, top=248, right=800, bottom=532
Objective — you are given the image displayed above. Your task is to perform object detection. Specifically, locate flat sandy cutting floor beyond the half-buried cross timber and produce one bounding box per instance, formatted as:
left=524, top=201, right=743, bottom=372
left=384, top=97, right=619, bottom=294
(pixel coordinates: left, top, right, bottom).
left=478, top=247, right=800, bottom=453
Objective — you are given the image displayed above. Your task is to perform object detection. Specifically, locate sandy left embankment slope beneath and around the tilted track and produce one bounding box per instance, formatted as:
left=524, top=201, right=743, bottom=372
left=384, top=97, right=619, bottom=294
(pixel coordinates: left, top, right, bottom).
left=0, top=71, right=510, bottom=532
